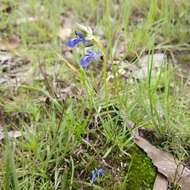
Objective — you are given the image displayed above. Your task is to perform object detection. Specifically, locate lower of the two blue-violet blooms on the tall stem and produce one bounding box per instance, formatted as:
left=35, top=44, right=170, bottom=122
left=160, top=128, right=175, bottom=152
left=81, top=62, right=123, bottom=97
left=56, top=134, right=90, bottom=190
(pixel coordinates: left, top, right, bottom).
left=80, top=50, right=99, bottom=67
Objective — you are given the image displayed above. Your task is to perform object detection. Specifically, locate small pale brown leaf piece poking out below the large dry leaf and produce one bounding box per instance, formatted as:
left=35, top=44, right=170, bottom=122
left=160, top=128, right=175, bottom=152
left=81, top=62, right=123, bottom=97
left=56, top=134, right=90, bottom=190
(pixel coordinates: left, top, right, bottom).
left=153, top=174, right=168, bottom=190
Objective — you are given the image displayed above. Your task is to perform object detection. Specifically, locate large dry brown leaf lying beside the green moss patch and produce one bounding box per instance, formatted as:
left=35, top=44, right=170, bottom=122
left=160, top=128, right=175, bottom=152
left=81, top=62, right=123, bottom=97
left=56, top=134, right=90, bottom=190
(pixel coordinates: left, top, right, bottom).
left=134, top=135, right=190, bottom=190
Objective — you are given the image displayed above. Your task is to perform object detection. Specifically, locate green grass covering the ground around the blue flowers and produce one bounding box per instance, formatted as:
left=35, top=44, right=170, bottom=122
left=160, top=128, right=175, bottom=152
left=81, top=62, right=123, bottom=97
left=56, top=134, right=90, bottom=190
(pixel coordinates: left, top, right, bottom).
left=0, top=0, right=190, bottom=190
